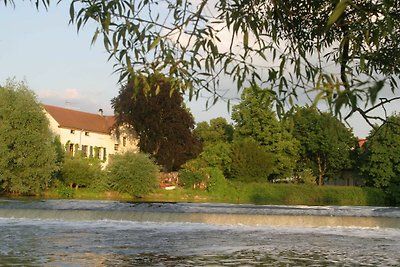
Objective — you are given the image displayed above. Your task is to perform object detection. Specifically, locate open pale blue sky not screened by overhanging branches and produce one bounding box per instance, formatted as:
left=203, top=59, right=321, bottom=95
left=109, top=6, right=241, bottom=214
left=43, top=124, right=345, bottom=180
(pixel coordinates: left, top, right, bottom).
left=0, top=1, right=399, bottom=138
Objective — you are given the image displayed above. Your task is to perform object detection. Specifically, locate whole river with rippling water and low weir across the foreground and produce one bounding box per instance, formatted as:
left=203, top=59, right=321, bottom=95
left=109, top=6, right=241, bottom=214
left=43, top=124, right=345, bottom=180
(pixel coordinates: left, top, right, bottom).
left=0, top=200, right=400, bottom=266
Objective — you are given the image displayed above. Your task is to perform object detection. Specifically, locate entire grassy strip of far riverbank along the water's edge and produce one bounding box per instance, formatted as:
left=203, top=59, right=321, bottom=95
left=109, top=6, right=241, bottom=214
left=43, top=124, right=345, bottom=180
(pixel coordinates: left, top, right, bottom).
left=31, top=183, right=386, bottom=206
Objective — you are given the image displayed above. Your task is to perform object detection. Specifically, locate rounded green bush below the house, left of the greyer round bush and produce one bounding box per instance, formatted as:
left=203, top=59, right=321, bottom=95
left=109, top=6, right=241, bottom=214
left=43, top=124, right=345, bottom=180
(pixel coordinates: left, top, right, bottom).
left=61, top=152, right=103, bottom=188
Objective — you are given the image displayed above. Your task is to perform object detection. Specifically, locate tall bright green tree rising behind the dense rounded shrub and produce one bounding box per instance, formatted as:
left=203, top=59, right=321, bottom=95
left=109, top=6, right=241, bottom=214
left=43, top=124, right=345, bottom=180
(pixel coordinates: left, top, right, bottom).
left=232, top=88, right=298, bottom=180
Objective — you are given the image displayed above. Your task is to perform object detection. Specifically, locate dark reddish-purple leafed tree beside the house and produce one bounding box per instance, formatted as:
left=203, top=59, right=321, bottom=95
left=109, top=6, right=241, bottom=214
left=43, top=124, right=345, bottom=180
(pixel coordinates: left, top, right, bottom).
left=112, top=75, right=201, bottom=170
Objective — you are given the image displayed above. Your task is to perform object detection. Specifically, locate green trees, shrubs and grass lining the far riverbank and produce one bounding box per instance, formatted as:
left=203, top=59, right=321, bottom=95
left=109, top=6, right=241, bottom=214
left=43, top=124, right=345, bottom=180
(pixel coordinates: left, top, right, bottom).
left=0, top=80, right=400, bottom=206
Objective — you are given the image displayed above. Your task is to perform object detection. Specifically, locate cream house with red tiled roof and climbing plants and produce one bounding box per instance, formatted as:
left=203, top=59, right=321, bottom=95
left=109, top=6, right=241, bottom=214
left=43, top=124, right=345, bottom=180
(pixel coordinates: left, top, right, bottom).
left=43, top=105, right=138, bottom=166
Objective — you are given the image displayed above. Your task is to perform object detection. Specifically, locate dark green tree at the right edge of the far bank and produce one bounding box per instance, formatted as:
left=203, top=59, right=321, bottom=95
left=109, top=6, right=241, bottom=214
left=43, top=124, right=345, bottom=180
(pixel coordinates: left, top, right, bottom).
left=361, top=115, right=400, bottom=204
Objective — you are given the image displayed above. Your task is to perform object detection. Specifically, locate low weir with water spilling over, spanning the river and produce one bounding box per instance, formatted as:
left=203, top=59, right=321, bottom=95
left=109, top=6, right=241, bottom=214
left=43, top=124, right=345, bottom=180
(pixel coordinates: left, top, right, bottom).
left=0, top=200, right=400, bottom=228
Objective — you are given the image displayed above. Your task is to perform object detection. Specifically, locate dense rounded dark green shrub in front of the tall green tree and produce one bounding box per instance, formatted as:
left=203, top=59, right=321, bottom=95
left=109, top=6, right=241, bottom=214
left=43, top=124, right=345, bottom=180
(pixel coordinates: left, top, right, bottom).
left=231, top=138, right=275, bottom=182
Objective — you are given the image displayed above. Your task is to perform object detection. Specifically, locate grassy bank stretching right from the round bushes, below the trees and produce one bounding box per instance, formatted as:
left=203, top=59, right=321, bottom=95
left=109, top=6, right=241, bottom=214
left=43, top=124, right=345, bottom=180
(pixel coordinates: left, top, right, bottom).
left=144, top=183, right=385, bottom=206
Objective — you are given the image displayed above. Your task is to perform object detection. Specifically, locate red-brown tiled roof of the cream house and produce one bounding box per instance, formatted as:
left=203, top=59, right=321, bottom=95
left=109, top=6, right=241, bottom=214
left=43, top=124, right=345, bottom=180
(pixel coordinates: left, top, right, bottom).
left=43, top=105, right=115, bottom=134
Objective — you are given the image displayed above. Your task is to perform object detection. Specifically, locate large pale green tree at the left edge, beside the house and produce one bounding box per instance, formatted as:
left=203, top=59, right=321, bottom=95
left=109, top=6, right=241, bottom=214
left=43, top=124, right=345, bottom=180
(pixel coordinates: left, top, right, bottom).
left=0, top=80, right=57, bottom=194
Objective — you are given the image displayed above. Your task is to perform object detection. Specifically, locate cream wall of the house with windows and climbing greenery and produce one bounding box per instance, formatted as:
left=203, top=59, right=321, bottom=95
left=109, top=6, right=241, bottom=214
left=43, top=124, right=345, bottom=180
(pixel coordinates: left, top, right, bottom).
left=45, top=111, right=139, bottom=166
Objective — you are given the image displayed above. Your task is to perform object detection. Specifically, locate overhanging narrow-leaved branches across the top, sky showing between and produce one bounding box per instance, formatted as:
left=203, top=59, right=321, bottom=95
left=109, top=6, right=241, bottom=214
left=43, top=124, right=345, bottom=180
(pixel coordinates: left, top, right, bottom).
left=4, top=0, right=400, bottom=127
